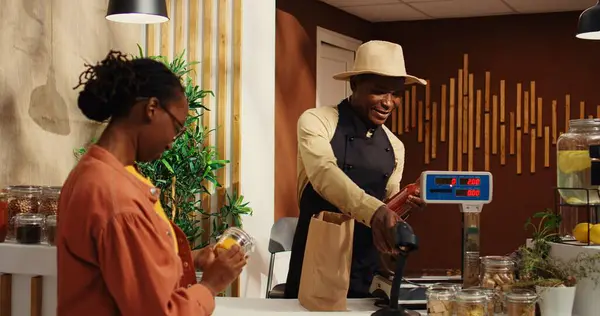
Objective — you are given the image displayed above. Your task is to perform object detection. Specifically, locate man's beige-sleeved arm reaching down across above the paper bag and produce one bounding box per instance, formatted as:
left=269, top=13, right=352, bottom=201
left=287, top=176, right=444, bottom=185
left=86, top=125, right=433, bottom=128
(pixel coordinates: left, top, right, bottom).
left=298, top=108, right=385, bottom=226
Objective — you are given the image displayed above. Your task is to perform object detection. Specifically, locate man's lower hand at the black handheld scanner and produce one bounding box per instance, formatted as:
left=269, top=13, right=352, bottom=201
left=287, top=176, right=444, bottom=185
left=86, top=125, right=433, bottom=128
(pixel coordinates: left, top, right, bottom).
left=371, top=205, right=402, bottom=254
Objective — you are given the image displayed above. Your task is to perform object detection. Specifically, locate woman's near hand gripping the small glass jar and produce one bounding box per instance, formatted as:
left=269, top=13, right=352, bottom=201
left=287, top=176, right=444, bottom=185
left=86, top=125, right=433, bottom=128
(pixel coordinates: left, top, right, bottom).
left=200, top=245, right=246, bottom=295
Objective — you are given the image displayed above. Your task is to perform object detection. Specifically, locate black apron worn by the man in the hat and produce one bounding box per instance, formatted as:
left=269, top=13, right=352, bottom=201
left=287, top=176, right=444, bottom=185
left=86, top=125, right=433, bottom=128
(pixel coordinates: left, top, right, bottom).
left=285, top=100, right=395, bottom=298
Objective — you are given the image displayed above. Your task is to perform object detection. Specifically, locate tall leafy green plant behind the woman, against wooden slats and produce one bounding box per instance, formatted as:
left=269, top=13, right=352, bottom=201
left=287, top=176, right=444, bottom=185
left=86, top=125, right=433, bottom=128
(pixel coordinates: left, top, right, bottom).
left=74, top=45, right=252, bottom=249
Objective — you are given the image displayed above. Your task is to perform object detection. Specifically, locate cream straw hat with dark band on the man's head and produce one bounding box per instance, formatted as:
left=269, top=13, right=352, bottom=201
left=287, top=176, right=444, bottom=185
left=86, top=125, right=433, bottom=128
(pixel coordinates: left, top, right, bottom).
left=333, top=41, right=427, bottom=85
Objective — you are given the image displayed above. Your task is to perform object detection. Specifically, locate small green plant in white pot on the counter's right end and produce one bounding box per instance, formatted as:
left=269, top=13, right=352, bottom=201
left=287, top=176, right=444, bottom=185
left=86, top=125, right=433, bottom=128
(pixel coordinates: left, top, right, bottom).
left=513, top=209, right=600, bottom=316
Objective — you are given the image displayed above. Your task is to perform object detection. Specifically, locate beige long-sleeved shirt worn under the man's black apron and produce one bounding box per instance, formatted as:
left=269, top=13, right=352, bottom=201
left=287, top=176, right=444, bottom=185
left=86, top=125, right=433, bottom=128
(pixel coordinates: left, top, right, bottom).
left=298, top=106, right=404, bottom=226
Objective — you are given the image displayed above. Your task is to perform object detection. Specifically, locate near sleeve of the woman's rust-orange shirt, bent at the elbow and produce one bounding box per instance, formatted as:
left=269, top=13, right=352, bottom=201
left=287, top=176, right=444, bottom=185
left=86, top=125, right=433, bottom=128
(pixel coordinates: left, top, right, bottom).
left=97, top=210, right=215, bottom=316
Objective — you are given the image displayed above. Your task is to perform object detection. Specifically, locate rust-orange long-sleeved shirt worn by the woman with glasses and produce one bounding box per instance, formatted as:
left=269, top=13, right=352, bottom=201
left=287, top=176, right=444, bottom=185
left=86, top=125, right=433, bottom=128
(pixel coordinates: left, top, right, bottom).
left=57, top=146, right=215, bottom=316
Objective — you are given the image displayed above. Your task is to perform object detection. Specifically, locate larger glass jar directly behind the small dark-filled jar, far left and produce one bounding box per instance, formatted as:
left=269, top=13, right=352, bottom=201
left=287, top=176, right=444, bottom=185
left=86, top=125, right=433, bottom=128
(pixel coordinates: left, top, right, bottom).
left=6, top=185, right=42, bottom=240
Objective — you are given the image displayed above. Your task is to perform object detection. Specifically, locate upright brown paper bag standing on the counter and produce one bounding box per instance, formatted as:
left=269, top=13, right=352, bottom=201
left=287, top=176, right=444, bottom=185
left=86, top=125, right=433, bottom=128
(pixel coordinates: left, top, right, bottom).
left=298, top=211, right=354, bottom=311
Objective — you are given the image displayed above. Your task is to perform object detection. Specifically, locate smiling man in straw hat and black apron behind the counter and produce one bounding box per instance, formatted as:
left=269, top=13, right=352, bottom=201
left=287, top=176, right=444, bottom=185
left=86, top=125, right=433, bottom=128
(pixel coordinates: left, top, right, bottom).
left=285, top=41, right=427, bottom=298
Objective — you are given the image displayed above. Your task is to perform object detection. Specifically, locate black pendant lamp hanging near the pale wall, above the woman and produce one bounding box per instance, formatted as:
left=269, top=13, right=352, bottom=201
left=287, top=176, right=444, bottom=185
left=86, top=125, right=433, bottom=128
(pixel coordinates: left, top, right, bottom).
left=106, top=0, right=169, bottom=24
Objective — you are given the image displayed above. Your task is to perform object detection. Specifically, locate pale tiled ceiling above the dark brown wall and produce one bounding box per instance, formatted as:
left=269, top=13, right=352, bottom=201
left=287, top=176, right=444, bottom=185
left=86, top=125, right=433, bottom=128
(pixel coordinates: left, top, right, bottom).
left=321, top=0, right=597, bottom=22
